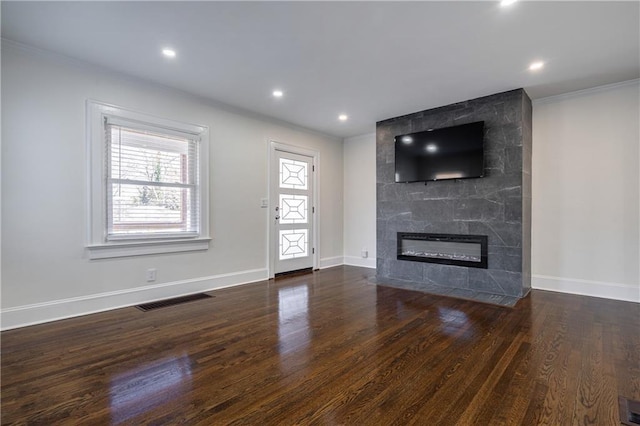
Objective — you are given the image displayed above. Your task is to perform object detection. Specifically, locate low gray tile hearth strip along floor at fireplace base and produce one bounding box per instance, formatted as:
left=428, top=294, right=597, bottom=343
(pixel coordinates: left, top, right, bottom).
left=369, top=276, right=528, bottom=308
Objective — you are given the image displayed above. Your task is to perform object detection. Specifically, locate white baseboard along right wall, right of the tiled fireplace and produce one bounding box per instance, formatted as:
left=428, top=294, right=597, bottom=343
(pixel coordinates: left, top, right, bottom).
left=531, top=275, right=640, bottom=303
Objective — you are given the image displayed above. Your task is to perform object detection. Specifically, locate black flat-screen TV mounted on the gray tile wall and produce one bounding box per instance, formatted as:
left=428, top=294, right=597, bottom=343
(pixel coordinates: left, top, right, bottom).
left=395, top=121, right=484, bottom=182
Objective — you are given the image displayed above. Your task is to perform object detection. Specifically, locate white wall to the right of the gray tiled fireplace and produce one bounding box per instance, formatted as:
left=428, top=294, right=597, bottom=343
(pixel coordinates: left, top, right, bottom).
left=532, top=80, right=640, bottom=302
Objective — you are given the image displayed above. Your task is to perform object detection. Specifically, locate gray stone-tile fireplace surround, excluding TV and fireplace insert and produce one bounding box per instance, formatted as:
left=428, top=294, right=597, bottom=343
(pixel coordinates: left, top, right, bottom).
left=375, top=89, right=532, bottom=306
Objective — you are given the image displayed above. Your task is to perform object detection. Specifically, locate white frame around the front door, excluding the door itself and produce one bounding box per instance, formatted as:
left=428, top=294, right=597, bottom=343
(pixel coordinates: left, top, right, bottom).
left=267, top=139, right=320, bottom=279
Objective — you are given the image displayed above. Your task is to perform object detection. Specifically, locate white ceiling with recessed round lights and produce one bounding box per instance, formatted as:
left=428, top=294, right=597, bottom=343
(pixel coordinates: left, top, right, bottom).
left=2, top=1, right=640, bottom=137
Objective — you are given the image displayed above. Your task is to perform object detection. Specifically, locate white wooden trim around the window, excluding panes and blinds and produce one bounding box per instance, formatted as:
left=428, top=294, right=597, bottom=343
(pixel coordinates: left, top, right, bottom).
left=86, top=100, right=211, bottom=259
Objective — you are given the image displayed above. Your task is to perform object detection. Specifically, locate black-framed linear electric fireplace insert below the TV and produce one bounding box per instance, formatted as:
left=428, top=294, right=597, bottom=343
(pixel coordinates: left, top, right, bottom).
left=398, top=232, right=488, bottom=269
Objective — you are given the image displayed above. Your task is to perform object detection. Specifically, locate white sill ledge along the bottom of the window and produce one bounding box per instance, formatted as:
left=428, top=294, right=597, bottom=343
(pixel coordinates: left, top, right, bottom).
left=87, top=238, right=211, bottom=260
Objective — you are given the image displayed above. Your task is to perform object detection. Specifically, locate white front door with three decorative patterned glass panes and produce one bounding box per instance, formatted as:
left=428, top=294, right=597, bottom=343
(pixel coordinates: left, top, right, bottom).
left=270, top=149, right=315, bottom=274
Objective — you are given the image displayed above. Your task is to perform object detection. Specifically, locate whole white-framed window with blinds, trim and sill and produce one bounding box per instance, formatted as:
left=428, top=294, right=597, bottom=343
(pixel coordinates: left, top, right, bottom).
left=88, top=101, right=209, bottom=258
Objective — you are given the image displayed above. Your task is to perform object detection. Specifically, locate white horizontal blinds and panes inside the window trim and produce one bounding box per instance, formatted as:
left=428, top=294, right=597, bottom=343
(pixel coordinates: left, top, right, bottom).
left=105, top=118, right=200, bottom=240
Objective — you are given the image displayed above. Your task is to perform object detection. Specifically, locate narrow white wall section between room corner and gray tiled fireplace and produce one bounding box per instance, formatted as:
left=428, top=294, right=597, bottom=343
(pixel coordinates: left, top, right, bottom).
left=344, top=133, right=376, bottom=268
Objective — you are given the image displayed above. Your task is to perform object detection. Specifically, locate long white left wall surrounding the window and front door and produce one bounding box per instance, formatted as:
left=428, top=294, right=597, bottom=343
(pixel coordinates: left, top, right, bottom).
left=2, top=42, right=343, bottom=328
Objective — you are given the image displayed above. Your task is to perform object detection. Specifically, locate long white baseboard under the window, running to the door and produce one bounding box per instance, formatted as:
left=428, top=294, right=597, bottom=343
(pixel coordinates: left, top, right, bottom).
left=0, top=269, right=268, bottom=330
